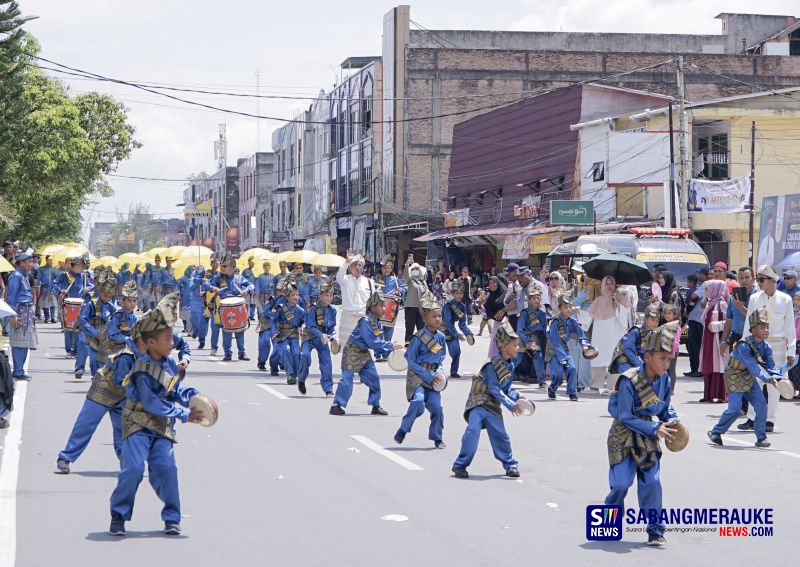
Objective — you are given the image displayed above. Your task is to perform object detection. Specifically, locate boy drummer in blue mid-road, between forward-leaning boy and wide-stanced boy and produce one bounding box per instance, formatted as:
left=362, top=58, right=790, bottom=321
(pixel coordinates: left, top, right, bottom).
left=394, top=292, right=446, bottom=449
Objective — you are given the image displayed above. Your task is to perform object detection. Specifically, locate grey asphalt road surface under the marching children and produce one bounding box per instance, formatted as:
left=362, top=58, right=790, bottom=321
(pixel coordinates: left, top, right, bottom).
left=0, top=310, right=800, bottom=567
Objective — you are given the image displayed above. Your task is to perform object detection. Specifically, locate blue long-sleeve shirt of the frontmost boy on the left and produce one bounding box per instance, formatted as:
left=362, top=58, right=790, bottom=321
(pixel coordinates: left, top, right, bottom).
left=125, top=354, right=198, bottom=424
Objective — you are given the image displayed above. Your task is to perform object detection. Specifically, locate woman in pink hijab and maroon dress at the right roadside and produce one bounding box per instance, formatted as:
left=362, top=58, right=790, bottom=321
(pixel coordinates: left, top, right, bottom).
left=700, top=280, right=728, bottom=403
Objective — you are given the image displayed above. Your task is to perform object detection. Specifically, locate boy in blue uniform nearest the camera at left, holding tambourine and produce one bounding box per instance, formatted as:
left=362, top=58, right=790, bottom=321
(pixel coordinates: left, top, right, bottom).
left=109, top=301, right=199, bottom=535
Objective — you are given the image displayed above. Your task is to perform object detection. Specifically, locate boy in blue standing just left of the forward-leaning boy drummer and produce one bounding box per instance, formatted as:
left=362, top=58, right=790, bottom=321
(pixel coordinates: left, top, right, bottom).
left=297, top=280, right=336, bottom=397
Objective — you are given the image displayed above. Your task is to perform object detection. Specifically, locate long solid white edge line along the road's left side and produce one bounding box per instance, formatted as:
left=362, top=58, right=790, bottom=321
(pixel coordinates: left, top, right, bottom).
left=0, top=382, right=28, bottom=567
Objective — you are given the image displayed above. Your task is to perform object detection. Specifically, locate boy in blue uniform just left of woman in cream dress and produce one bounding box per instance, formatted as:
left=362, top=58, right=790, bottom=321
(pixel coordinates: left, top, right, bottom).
left=547, top=293, right=589, bottom=402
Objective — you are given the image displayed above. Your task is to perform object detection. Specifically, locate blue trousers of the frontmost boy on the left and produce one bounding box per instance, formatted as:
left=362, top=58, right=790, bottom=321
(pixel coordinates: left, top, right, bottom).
left=111, top=430, right=181, bottom=523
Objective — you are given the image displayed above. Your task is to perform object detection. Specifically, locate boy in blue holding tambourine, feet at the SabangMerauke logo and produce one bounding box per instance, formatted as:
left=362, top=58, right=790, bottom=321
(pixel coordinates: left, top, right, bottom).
left=605, top=321, right=678, bottom=546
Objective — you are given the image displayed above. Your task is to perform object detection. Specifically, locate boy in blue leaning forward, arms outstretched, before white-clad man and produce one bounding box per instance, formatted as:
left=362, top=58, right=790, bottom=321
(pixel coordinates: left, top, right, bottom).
left=329, top=291, right=403, bottom=415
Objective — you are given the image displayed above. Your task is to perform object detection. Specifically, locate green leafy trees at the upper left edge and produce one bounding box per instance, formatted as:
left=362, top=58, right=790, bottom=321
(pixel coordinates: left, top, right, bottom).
left=0, top=0, right=140, bottom=245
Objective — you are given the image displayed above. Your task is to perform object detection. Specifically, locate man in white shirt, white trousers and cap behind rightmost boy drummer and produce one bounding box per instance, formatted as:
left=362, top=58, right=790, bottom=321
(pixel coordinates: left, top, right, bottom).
left=738, top=266, right=797, bottom=432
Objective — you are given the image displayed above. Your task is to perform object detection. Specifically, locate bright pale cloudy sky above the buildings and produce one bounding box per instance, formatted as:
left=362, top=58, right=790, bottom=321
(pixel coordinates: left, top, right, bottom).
left=18, top=0, right=800, bottom=242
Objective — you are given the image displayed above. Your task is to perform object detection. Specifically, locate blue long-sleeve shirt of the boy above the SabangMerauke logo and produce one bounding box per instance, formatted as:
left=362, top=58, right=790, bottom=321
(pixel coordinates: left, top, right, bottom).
left=608, top=364, right=678, bottom=439
